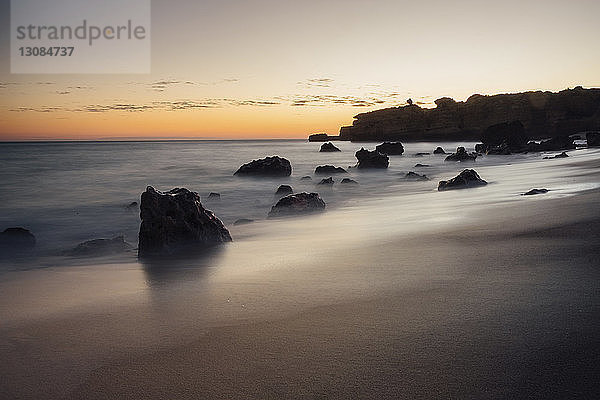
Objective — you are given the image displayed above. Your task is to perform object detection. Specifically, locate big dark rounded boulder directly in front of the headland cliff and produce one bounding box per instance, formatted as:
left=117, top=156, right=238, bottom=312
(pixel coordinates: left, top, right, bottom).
left=475, top=121, right=529, bottom=154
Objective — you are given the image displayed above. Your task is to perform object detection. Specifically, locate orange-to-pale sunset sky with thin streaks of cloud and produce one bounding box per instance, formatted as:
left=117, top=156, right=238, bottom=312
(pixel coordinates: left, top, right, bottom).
left=0, top=0, right=600, bottom=140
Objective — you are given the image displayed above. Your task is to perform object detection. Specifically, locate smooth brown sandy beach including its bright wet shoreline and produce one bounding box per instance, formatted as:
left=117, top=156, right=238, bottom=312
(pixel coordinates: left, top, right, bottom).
left=0, top=145, right=600, bottom=399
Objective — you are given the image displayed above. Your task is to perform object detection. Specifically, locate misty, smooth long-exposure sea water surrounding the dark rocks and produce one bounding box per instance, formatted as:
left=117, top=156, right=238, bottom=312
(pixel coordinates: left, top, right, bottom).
left=0, top=140, right=598, bottom=268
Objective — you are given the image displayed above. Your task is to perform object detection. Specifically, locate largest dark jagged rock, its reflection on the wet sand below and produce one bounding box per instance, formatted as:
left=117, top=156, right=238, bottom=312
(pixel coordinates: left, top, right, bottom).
left=139, top=186, right=231, bottom=256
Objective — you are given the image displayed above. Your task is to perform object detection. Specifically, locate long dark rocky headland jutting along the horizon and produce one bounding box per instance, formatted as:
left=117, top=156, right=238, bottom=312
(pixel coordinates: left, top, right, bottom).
left=312, top=86, right=600, bottom=141
